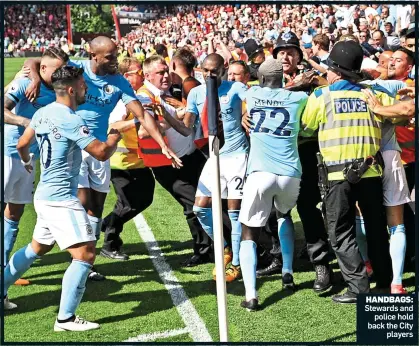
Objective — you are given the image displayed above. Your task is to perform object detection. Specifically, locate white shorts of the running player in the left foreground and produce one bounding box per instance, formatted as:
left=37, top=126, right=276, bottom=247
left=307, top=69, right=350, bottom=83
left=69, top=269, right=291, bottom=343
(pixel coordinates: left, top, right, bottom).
left=33, top=200, right=96, bottom=250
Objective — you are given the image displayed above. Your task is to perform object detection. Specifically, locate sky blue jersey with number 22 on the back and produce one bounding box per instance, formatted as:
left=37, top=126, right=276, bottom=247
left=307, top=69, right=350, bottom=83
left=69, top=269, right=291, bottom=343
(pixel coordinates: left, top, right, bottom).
left=246, top=86, right=308, bottom=178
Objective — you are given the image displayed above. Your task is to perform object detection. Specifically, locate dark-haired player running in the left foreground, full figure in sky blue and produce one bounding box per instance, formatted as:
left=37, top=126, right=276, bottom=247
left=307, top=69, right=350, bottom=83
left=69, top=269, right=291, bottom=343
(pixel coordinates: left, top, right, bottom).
left=4, top=66, right=121, bottom=331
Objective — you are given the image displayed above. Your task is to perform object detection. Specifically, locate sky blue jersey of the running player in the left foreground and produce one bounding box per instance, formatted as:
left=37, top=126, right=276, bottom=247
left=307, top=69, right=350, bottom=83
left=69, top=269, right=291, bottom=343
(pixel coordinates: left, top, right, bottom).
left=29, top=102, right=95, bottom=201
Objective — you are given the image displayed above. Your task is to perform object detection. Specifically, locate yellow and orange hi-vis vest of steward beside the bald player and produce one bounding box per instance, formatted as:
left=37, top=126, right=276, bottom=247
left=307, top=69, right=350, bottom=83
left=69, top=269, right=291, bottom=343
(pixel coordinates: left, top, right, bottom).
left=109, top=113, right=145, bottom=170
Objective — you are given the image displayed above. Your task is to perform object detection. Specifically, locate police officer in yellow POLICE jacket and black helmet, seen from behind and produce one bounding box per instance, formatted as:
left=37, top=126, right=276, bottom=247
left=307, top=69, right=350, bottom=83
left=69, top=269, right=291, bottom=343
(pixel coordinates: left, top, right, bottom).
left=302, top=41, right=391, bottom=303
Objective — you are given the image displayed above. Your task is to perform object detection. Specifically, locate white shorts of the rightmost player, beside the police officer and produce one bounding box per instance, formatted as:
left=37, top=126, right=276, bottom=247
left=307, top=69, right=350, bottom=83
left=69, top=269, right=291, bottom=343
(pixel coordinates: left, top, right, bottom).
left=382, top=150, right=410, bottom=207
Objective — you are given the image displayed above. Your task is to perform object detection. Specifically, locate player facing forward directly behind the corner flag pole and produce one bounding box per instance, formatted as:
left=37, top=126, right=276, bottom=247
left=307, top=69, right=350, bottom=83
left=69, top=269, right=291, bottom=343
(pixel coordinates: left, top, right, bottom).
left=184, top=53, right=249, bottom=282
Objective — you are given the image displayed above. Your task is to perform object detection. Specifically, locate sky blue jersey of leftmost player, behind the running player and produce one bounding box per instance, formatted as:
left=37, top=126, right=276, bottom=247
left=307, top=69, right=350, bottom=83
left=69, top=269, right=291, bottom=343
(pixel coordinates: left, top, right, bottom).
left=4, top=78, right=55, bottom=159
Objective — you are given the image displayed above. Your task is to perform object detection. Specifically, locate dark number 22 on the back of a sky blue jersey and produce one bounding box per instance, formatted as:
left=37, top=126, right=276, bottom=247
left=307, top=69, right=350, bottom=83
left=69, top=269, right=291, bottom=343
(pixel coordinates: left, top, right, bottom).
left=249, top=107, right=291, bottom=137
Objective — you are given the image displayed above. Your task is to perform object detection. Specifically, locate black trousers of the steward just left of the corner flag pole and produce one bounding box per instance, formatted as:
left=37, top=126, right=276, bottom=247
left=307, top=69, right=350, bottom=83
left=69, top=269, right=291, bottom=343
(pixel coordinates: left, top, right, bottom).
left=153, top=150, right=212, bottom=257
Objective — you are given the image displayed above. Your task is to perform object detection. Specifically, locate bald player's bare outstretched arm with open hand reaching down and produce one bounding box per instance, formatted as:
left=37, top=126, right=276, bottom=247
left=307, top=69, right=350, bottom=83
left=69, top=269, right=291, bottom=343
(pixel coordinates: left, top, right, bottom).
left=126, top=100, right=182, bottom=168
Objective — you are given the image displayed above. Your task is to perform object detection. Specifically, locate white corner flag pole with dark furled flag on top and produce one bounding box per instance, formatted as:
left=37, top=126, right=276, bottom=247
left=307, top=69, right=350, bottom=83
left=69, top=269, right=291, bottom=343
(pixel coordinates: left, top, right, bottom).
left=206, top=76, right=228, bottom=342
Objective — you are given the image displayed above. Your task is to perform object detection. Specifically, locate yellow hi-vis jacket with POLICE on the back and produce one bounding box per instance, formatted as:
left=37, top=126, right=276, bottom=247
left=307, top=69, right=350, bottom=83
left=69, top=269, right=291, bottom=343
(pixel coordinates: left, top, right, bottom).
left=300, top=80, right=394, bottom=180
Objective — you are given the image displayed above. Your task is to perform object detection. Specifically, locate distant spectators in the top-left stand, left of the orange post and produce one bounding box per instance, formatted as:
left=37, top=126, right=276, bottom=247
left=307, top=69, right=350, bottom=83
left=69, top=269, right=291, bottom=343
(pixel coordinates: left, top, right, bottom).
left=3, top=4, right=68, bottom=57
